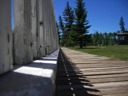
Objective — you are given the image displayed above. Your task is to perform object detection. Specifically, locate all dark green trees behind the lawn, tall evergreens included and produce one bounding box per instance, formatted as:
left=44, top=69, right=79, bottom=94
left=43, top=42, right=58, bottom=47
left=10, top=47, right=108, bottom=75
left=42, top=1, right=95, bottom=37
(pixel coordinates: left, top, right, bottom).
left=57, top=0, right=127, bottom=48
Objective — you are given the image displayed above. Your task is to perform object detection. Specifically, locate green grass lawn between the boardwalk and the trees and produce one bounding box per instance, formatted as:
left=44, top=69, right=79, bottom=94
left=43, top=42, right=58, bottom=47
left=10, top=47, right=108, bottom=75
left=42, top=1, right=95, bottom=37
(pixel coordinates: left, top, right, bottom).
left=69, top=45, right=128, bottom=61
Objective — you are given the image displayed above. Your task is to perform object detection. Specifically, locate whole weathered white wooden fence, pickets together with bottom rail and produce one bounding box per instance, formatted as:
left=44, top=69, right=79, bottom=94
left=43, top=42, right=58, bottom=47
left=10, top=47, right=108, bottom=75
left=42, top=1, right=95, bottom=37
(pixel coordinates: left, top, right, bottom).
left=0, top=0, right=59, bottom=96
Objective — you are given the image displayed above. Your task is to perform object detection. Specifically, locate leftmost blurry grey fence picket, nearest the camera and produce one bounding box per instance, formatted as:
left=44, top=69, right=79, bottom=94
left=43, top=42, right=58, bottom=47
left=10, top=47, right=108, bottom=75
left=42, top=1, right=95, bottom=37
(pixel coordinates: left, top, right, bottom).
left=0, top=0, right=13, bottom=74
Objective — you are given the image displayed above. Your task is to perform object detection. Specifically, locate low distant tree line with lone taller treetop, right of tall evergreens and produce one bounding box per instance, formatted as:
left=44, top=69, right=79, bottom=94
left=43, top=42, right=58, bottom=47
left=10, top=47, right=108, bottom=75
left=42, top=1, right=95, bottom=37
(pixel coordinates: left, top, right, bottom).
left=88, top=17, right=128, bottom=46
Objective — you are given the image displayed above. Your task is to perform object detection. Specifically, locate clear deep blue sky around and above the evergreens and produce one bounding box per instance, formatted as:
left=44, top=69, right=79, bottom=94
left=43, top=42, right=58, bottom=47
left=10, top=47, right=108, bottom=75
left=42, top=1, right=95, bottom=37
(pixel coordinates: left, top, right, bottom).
left=54, top=0, right=128, bottom=33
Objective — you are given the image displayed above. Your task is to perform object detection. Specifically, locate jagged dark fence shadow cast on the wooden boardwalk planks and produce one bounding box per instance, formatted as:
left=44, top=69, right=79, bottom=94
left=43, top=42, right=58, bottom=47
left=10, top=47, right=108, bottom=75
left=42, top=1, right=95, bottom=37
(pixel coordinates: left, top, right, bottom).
left=56, top=50, right=100, bottom=96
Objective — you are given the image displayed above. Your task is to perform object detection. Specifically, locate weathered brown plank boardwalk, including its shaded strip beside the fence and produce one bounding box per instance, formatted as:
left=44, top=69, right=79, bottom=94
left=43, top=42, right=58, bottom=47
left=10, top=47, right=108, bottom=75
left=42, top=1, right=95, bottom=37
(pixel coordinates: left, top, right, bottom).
left=56, top=48, right=128, bottom=96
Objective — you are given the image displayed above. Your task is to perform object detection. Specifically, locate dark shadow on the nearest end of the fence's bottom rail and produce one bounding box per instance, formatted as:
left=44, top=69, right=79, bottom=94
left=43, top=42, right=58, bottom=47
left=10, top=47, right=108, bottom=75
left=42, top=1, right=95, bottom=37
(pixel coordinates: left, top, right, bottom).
left=0, top=68, right=55, bottom=96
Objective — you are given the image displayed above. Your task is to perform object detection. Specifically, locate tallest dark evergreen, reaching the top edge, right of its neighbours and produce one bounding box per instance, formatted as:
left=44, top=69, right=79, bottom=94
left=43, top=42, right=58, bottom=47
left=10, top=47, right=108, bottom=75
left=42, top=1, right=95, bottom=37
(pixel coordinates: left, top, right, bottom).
left=75, top=0, right=90, bottom=48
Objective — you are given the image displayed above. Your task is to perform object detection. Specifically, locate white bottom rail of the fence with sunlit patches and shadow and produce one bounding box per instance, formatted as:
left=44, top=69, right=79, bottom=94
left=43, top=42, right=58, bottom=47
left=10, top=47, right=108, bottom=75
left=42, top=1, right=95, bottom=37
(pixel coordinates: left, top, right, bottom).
left=0, top=57, right=57, bottom=96
